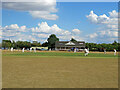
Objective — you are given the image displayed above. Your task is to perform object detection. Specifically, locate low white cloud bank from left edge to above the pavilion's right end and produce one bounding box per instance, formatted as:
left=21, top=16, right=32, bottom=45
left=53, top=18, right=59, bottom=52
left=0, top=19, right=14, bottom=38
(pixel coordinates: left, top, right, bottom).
left=2, top=22, right=84, bottom=42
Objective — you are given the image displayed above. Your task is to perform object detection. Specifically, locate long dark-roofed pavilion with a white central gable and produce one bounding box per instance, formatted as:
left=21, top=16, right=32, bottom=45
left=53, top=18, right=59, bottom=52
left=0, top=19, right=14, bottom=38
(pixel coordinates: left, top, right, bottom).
left=55, top=41, right=85, bottom=51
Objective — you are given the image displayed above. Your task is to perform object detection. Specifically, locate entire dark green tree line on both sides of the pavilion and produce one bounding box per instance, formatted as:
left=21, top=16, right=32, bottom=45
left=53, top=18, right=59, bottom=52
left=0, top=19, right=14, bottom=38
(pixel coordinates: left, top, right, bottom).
left=2, top=34, right=120, bottom=51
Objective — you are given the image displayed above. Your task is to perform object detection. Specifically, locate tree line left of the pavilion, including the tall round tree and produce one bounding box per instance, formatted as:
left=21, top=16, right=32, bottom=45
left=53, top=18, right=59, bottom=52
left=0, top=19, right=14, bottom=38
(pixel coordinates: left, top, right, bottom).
left=1, top=34, right=59, bottom=50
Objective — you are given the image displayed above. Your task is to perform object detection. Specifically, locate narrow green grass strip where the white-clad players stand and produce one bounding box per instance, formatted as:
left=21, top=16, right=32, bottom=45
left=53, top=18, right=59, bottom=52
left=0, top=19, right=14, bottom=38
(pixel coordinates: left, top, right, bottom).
left=2, top=52, right=118, bottom=58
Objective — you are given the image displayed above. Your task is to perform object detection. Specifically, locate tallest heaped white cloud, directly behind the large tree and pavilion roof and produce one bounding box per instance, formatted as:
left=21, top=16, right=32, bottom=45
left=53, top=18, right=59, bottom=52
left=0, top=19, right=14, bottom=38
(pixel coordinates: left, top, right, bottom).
left=32, top=22, right=82, bottom=40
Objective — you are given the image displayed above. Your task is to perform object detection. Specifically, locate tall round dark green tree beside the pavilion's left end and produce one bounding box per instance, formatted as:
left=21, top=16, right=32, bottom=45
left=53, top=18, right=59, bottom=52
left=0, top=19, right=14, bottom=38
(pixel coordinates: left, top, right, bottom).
left=47, top=34, right=59, bottom=50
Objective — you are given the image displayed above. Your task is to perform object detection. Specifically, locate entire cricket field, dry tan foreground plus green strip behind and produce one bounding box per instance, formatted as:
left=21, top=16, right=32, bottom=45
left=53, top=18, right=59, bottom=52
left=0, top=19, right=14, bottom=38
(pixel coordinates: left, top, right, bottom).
left=2, top=51, right=118, bottom=88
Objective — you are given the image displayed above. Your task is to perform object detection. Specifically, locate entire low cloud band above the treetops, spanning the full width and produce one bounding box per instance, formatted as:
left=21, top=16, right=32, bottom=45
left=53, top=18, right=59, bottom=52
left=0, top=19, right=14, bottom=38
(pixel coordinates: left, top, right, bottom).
left=2, top=22, right=118, bottom=43
